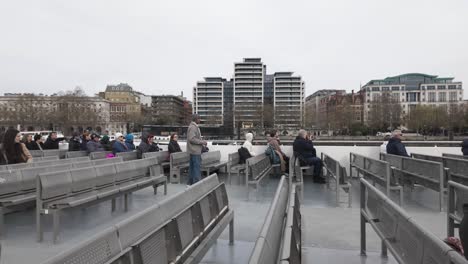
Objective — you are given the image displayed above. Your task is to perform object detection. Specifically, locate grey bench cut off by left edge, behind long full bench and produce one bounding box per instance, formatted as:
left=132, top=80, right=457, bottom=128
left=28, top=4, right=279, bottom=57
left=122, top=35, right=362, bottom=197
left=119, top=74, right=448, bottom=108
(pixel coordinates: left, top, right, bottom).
left=0, top=164, right=71, bottom=234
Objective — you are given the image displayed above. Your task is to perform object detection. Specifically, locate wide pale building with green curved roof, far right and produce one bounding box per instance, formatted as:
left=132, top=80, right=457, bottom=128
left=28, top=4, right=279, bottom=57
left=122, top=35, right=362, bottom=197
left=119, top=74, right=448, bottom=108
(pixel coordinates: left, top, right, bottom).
left=361, top=73, right=463, bottom=122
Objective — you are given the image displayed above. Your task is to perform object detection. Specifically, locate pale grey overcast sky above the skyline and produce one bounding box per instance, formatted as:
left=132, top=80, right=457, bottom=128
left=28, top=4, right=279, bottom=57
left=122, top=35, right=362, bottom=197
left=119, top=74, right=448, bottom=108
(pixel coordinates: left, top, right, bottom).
left=0, top=0, right=468, bottom=99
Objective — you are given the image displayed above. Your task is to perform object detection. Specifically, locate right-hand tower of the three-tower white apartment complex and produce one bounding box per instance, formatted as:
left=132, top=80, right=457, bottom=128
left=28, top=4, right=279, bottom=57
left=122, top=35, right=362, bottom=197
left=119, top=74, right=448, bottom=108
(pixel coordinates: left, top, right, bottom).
left=273, top=72, right=305, bottom=129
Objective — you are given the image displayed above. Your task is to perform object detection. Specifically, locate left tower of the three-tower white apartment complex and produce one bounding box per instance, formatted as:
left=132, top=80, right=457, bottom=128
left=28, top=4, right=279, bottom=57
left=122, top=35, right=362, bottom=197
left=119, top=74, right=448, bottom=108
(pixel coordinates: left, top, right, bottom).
left=193, top=77, right=226, bottom=127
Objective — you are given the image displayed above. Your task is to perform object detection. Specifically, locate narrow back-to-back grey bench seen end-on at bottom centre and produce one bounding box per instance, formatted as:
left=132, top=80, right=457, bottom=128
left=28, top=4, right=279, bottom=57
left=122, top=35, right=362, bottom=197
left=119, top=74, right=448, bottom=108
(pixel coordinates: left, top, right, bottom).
left=249, top=176, right=302, bottom=264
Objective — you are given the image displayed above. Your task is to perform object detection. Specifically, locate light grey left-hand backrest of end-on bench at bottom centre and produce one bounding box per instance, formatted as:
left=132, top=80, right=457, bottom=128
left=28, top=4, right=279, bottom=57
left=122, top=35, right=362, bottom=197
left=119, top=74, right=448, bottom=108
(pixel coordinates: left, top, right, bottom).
left=249, top=176, right=289, bottom=264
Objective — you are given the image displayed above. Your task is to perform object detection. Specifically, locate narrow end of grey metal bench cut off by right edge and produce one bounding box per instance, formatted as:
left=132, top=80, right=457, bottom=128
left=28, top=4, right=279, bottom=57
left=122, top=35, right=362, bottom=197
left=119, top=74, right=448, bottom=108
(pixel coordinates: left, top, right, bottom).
left=447, top=181, right=468, bottom=236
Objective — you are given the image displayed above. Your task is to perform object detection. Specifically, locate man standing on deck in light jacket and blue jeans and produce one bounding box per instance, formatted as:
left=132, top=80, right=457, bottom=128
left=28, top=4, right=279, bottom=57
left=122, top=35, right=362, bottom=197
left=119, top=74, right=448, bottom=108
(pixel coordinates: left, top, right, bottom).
left=187, top=114, right=206, bottom=185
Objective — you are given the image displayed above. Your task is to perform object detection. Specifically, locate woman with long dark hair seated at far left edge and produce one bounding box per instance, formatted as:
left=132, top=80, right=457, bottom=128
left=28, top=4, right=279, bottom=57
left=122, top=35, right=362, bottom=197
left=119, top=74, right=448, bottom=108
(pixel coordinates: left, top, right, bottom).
left=2, top=129, right=32, bottom=164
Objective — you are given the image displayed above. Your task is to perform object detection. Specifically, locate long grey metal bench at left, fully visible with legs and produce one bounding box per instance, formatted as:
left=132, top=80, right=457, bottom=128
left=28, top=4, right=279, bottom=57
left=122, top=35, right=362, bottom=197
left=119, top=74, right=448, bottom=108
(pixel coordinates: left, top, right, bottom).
left=36, top=159, right=167, bottom=243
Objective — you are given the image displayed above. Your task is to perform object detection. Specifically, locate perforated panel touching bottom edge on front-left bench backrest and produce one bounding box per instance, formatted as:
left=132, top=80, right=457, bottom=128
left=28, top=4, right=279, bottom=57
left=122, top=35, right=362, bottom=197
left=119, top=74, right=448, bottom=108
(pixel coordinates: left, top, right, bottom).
left=139, top=229, right=169, bottom=264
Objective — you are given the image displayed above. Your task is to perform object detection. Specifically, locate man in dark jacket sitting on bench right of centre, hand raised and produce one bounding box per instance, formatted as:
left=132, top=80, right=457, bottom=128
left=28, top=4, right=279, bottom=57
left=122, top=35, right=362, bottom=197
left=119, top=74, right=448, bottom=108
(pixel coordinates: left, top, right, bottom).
left=293, top=129, right=325, bottom=183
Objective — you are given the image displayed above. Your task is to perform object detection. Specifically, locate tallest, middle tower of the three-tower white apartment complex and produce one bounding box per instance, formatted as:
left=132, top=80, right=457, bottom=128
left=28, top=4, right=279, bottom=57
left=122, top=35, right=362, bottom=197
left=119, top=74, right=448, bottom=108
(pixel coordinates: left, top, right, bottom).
left=233, top=58, right=265, bottom=128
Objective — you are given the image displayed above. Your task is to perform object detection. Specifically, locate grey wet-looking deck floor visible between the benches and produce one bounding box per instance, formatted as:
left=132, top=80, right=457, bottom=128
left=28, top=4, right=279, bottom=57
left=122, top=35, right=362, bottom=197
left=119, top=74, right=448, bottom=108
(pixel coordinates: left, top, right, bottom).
left=0, top=169, right=452, bottom=264
